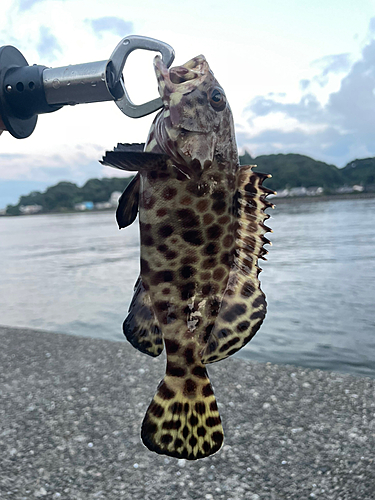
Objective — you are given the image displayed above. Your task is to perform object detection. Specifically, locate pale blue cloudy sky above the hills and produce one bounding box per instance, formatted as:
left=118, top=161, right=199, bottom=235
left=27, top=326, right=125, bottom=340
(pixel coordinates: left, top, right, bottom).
left=0, top=0, right=375, bottom=208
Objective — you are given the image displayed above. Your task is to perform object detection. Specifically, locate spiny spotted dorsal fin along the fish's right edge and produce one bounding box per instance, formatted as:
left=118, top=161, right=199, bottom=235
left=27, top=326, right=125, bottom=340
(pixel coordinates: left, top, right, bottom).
left=202, top=165, right=274, bottom=363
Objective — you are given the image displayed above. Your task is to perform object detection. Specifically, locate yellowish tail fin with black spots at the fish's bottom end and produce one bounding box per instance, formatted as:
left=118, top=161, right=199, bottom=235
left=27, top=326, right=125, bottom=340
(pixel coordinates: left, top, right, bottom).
left=141, top=374, right=224, bottom=460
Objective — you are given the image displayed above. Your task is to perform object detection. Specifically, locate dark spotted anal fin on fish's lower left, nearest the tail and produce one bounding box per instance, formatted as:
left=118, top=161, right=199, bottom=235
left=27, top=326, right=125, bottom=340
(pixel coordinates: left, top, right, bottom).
left=123, top=277, right=164, bottom=357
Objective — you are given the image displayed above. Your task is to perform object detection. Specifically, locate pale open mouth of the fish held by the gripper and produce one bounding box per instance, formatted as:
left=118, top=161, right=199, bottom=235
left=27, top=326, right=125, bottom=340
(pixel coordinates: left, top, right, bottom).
left=154, top=55, right=210, bottom=94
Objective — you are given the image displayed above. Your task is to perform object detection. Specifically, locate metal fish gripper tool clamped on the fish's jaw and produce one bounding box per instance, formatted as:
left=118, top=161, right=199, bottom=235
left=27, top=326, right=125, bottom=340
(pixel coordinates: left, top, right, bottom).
left=0, top=35, right=174, bottom=139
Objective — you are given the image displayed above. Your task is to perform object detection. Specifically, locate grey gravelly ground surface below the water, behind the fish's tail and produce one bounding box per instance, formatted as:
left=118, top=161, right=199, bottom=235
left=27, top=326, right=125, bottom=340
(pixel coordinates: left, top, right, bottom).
left=0, top=327, right=375, bottom=500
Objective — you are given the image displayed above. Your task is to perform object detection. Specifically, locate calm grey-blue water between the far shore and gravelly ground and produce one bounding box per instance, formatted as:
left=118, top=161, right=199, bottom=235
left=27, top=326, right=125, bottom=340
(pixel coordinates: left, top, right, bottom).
left=0, top=199, right=375, bottom=377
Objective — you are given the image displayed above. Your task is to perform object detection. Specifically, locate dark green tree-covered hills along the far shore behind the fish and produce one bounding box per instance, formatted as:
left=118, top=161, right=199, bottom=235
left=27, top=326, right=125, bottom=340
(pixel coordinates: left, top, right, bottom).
left=7, top=152, right=375, bottom=215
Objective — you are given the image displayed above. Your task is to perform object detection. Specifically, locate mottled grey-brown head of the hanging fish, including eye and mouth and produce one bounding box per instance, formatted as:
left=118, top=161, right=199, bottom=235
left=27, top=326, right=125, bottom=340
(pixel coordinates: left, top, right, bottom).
left=153, top=55, right=238, bottom=173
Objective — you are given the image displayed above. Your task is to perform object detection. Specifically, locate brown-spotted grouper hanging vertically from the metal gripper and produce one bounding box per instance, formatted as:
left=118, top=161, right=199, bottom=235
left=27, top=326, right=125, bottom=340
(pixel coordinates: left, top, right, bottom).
left=102, top=55, right=274, bottom=460
